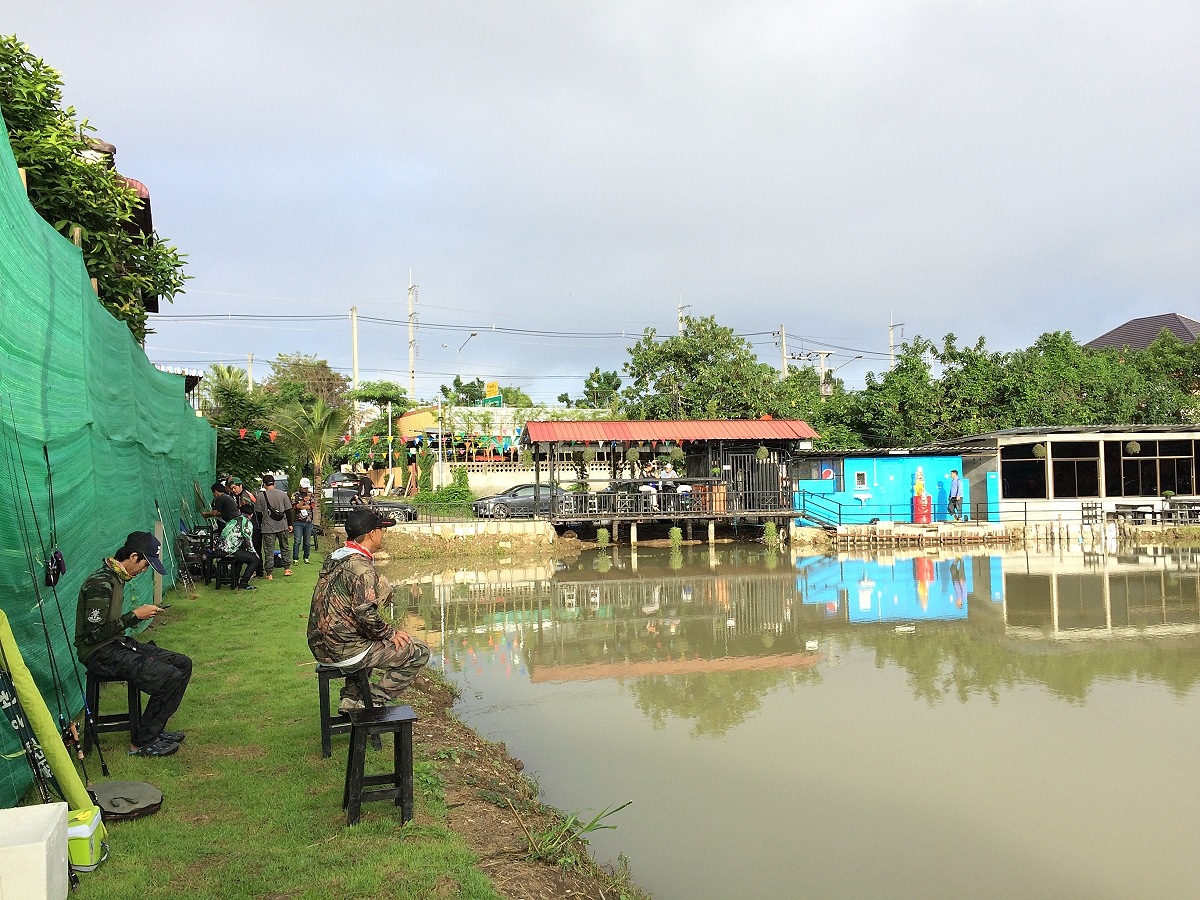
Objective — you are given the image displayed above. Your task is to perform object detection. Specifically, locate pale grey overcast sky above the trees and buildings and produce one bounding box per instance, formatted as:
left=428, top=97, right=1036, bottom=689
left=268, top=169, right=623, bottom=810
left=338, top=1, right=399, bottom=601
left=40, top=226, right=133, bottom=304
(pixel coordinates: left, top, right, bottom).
left=0, top=0, right=1200, bottom=402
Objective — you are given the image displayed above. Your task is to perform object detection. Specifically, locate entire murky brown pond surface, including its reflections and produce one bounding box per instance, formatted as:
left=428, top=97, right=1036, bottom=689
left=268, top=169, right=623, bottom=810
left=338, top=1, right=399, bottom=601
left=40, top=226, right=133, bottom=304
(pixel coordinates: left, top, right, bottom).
left=384, top=545, right=1200, bottom=900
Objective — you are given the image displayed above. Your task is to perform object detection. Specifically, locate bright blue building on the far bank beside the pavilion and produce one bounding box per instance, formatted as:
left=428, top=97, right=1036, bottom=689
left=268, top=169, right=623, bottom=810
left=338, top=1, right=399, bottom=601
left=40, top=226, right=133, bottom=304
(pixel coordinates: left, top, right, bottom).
left=793, top=450, right=971, bottom=524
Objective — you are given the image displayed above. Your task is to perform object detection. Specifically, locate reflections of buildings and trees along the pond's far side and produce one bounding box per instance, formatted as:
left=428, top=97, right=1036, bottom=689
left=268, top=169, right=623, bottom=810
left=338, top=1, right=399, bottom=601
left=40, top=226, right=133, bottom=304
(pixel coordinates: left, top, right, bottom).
left=386, top=547, right=1200, bottom=734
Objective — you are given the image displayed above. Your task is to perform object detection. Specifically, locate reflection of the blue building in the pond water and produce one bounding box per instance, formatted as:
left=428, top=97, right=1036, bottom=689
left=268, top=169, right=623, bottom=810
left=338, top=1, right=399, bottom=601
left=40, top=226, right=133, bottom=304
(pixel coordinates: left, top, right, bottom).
left=796, top=557, right=974, bottom=623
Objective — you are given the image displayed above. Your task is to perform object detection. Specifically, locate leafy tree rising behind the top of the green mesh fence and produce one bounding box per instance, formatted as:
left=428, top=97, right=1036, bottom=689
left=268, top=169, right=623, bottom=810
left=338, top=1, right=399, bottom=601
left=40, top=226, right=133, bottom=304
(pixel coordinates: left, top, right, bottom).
left=0, top=36, right=187, bottom=342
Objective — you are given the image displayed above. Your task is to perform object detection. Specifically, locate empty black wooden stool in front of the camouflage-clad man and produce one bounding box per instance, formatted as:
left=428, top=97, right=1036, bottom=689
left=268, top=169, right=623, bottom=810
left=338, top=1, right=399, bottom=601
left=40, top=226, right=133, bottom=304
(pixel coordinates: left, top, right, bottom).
left=342, top=707, right=416, bottom=826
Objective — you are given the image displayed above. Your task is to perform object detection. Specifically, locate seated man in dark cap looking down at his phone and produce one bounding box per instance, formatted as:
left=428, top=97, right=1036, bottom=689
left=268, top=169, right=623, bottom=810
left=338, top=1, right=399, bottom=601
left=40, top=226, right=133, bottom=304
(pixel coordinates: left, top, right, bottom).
left=74, top=532, right=192, bottom=756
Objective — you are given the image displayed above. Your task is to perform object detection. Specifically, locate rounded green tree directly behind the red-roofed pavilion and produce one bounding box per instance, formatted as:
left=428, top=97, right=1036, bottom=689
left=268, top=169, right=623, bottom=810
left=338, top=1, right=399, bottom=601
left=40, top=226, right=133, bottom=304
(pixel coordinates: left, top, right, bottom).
left=622, top=316, right=779, bottom=419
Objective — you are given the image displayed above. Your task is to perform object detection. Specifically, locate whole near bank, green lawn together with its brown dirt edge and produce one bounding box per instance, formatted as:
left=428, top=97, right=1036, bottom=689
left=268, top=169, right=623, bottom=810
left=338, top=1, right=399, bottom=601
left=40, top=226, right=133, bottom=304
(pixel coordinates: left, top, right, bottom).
left=80, top=547, right=644, bottom=900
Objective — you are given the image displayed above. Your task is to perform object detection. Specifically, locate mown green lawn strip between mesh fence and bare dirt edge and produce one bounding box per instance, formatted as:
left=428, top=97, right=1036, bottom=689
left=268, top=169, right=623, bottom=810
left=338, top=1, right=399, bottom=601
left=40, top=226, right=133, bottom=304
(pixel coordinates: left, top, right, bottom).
left=82, top=549, right=499, bottom=900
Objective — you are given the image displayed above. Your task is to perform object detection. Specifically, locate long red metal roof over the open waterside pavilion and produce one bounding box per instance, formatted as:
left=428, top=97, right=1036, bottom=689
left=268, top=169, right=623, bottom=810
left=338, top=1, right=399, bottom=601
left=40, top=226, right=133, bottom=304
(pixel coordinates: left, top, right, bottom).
left=521, top=419, right=820, bottom=444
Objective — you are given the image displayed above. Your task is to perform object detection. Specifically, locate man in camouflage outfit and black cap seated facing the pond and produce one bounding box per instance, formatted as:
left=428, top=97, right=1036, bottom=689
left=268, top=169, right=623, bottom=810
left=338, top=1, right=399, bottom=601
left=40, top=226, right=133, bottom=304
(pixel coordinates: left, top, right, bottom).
left=308, top=506, right=430, bottom=713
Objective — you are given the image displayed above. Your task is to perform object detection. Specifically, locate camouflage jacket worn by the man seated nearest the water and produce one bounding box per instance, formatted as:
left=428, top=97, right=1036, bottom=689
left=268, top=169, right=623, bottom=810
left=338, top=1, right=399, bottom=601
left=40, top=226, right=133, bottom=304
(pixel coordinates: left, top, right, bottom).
left=308, top=547, right=396, bottom=664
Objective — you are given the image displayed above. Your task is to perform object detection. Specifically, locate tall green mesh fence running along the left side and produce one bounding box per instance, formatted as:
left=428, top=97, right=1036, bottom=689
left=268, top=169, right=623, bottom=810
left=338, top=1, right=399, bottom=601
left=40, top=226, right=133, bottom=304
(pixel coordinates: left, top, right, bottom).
left=0, top=109, right=216, bottom=806
